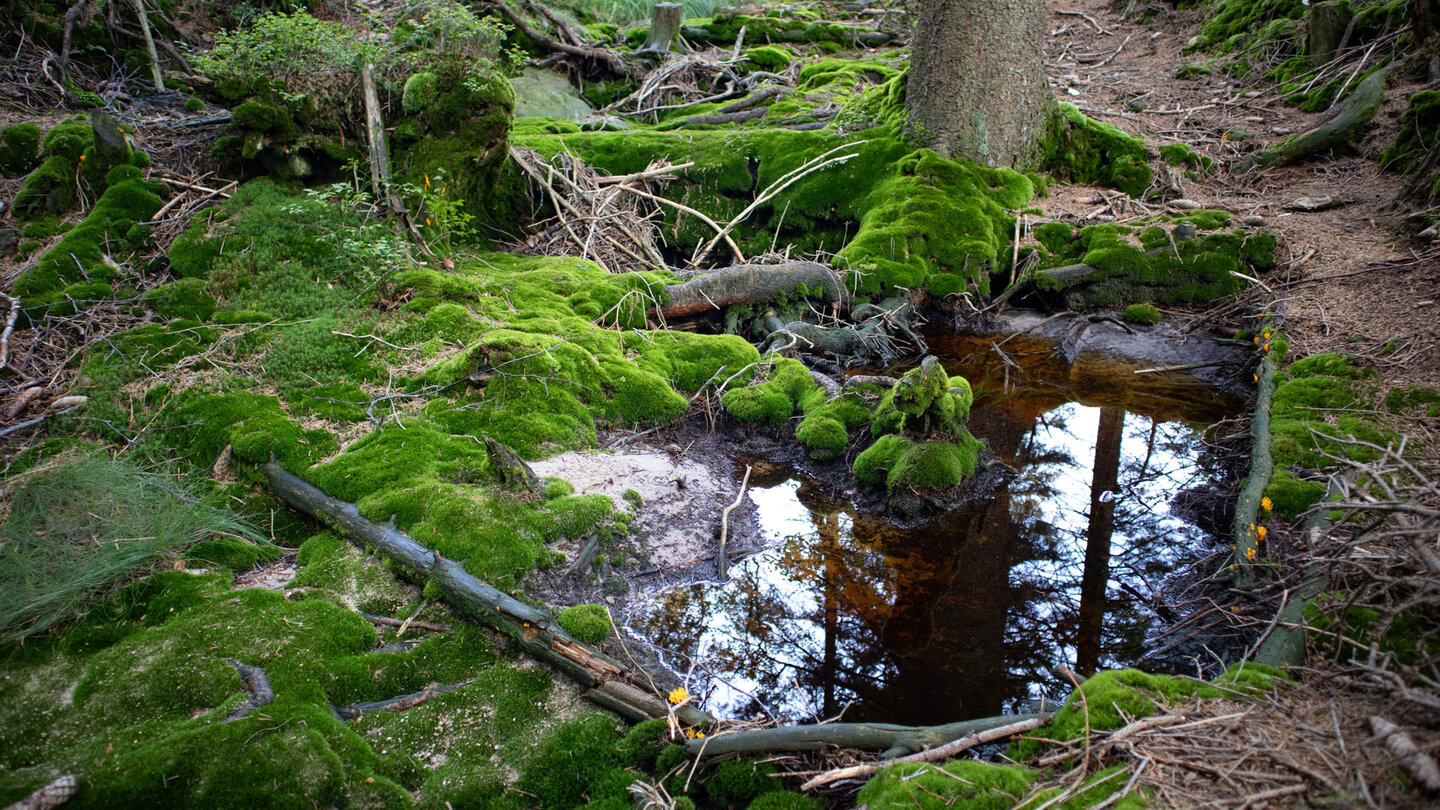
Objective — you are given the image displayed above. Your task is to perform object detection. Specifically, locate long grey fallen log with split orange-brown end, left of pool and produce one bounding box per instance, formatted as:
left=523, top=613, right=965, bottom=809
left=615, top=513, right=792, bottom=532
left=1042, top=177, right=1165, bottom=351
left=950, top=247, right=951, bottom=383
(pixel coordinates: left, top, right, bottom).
left=261, top=461, right=713, bottom=725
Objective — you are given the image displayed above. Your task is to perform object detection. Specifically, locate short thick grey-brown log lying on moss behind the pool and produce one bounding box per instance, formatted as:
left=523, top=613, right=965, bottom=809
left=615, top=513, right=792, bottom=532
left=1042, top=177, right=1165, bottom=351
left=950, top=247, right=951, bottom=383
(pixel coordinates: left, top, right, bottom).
left=652, top=261, right=847, bottom=320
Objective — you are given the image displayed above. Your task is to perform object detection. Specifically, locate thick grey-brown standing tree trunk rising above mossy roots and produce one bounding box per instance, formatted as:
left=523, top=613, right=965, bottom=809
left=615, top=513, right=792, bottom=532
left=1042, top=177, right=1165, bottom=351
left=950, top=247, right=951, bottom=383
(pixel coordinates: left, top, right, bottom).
left=906, top=0, right=1056, bottom=169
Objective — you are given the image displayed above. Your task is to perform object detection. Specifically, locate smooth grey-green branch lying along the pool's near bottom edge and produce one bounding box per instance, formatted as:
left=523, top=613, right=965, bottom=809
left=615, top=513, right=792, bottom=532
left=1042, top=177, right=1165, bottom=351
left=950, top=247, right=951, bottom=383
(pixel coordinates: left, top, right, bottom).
left=685, top=715, right=1041, bottom=757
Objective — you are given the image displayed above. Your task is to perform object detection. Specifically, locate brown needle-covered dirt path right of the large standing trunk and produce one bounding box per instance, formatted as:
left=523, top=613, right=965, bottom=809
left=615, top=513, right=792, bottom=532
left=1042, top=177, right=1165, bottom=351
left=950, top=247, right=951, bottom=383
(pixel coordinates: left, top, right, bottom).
left=1040, top=0, right=1440, bottom=388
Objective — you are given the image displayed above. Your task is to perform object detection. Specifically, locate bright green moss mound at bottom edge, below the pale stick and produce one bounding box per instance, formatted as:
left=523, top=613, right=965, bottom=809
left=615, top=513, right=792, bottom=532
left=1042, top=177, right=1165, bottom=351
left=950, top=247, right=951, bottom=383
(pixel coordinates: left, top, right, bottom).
left=857, top=760, right=1035, bottom=810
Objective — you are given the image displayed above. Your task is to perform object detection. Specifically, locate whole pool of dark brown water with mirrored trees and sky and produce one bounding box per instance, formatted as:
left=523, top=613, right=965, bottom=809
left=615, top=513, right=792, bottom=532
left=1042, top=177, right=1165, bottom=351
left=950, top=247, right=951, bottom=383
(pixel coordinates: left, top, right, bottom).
left=628, top=319, right=1247, bottom=725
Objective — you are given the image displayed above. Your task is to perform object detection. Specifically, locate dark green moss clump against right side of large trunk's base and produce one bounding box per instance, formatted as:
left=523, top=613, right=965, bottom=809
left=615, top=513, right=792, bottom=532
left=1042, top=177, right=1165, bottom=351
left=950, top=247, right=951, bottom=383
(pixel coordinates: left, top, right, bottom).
left=1041, top=102, right=1152, bottom=197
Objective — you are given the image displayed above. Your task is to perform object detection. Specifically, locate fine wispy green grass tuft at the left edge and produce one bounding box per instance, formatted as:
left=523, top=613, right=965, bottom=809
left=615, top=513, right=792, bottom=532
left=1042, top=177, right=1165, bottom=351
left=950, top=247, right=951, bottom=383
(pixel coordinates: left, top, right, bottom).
left=0, top=455, right=264, bottom=643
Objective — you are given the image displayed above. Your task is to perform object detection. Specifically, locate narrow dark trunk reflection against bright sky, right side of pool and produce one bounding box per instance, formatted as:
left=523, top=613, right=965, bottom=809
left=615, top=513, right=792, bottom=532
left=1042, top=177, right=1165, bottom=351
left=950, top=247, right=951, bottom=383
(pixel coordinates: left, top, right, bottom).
left=1076, top=406, right=1125, bottom=675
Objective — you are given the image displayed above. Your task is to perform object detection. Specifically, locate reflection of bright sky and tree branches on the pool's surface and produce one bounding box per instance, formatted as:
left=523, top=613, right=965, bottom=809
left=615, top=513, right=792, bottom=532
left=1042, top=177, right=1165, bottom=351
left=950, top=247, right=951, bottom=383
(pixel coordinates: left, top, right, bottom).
left=631, top=404, right=1204, bottom=722
